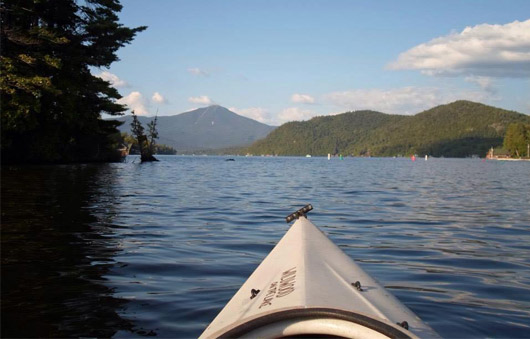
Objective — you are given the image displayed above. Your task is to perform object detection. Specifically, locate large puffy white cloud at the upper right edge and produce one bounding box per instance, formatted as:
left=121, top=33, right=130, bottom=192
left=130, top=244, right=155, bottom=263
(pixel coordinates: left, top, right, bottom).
left=388, top=19, right=530, bottom=77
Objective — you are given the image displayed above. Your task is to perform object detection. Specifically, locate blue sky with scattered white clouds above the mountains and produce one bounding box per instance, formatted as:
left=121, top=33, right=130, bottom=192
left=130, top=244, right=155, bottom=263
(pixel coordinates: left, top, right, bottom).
left=93, top=0, right=530, bottom=125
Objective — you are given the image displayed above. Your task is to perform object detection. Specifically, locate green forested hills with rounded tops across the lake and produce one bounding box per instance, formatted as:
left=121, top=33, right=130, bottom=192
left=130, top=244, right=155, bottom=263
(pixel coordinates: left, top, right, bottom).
left=247, top=101, right=530, bottom=157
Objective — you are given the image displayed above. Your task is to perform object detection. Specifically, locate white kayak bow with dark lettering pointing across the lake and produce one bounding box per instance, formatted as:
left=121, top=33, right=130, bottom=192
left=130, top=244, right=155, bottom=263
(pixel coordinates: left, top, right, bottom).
left=200, top=205, right=439, bottom=338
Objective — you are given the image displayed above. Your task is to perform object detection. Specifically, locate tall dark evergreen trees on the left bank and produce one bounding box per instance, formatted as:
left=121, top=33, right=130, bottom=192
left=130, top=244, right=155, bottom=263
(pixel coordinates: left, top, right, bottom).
left=0, top=0, right=145, bottom=162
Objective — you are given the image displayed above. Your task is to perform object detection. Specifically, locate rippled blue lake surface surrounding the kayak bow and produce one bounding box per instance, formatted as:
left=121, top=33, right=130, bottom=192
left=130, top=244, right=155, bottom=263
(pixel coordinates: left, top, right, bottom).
left=1, top=156, right=530, bottom=338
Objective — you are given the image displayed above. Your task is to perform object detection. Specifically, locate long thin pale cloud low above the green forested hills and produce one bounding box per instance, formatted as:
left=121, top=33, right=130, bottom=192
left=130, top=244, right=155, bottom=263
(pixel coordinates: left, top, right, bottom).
left=324, top=87, right=488, bottom=114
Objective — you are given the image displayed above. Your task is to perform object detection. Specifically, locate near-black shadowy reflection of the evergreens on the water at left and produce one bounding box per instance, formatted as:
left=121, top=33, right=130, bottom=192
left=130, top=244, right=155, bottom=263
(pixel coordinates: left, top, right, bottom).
left=2, top=165, right=131, bottom=337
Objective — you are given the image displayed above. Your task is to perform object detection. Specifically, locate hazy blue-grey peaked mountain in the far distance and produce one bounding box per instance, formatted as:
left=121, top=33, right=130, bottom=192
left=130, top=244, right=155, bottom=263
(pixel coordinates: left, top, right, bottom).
left=117, top=105, right=276, bottom=151
